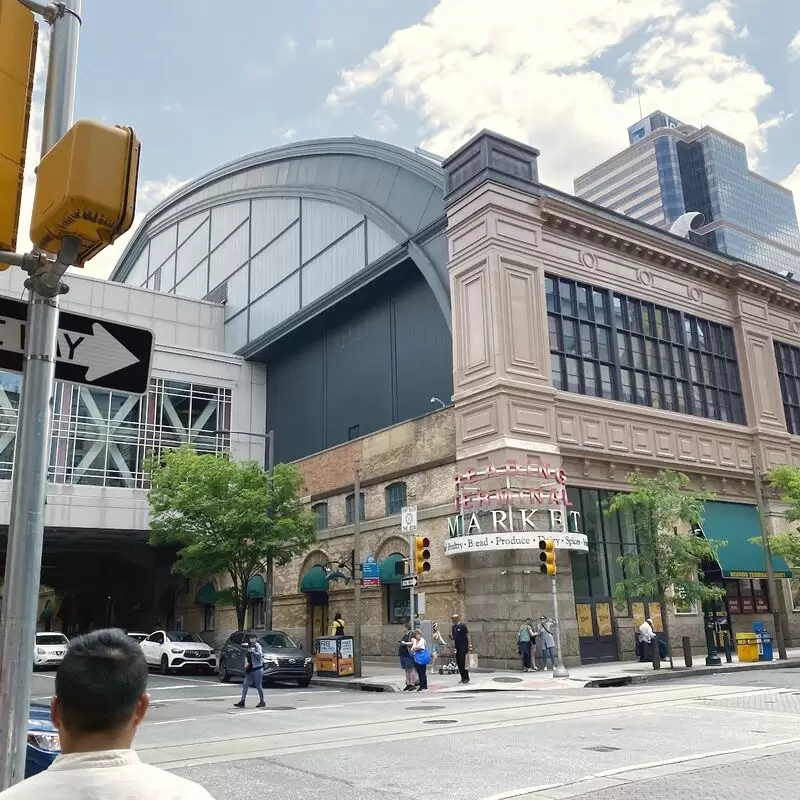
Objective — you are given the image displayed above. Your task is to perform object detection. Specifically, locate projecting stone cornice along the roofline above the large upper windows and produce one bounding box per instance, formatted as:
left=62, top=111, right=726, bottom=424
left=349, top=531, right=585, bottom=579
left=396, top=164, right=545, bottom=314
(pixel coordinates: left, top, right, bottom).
left=542, top=196, right=800, bottom=312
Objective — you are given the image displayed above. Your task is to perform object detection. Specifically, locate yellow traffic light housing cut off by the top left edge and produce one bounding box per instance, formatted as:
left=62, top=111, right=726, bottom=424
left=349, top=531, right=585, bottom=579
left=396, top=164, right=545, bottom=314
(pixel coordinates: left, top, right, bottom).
left=0, top=0, right=38, bottom=270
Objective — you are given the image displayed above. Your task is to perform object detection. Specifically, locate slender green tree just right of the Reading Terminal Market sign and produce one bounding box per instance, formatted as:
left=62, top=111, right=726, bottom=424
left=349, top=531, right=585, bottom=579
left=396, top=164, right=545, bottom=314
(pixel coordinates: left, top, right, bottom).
left=606, top=470, right=725, bottom=656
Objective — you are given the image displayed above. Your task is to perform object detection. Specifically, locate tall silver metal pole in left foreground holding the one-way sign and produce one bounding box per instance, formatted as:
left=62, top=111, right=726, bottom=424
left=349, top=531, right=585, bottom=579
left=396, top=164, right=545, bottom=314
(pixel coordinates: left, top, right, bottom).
left=0, top=0, right=81, bottom=790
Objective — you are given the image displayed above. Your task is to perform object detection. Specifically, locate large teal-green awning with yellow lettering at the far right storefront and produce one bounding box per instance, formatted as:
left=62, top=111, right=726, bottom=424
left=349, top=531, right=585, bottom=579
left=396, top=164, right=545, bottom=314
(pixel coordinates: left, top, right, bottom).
left=702, top=502, right=792, bottom=578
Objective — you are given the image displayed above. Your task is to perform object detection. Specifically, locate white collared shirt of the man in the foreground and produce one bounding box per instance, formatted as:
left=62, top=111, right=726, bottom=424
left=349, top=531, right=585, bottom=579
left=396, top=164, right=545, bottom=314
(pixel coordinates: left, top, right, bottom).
left=0, top=750, right=214, bottom=800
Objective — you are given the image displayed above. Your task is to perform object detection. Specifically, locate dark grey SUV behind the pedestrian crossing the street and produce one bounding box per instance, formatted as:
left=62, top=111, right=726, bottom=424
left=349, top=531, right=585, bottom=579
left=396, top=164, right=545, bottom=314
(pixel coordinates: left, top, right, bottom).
left=219, top=631, right=314, bottom=686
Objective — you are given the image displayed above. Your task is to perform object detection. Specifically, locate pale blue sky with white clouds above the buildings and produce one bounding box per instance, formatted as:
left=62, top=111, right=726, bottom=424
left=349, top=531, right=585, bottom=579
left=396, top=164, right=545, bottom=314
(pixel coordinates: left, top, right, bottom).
left=14, top=0, right=800, bottom=276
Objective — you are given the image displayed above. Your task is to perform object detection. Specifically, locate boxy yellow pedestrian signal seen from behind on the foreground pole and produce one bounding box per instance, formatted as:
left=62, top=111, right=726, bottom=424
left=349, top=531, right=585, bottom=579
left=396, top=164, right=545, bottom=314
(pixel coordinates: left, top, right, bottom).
left=31, top=120, right=140, bottom=266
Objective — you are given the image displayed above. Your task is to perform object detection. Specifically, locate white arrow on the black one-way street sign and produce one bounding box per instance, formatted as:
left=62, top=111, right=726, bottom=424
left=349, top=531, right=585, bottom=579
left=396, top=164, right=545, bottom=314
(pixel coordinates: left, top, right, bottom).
left=0, top=317, right=139, bottom=382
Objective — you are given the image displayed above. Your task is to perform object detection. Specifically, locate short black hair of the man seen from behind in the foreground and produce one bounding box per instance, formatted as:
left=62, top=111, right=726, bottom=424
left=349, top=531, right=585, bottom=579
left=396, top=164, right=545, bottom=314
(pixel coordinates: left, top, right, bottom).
left=56, top=628, right=147, bottom=733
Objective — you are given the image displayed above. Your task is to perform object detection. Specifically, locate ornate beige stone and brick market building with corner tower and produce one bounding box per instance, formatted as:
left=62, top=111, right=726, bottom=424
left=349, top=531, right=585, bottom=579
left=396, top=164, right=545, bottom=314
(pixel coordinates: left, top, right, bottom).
left=275, top=132, right=800, bottom=664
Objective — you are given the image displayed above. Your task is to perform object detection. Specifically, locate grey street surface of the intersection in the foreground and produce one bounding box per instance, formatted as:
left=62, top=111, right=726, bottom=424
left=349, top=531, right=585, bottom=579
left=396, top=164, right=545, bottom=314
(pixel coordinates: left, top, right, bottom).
left=34, top=670, right=800, bottom=800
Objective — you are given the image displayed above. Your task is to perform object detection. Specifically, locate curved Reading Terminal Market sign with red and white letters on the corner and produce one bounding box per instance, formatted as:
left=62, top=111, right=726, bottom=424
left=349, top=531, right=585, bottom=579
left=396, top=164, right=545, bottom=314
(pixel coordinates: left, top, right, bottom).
left=444, top=461, right=589, bottom=556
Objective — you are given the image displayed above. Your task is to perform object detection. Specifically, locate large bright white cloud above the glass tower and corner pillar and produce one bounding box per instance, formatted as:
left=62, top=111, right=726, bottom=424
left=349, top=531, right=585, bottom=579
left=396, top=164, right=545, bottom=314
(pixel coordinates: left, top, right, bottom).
left=328, top=0, right=777, bottom=190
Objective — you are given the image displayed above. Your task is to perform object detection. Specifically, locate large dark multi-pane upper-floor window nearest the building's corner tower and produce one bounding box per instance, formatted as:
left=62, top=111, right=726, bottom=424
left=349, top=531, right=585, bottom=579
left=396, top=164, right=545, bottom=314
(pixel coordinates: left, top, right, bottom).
left=545, top=275, right=748, bottom=425
